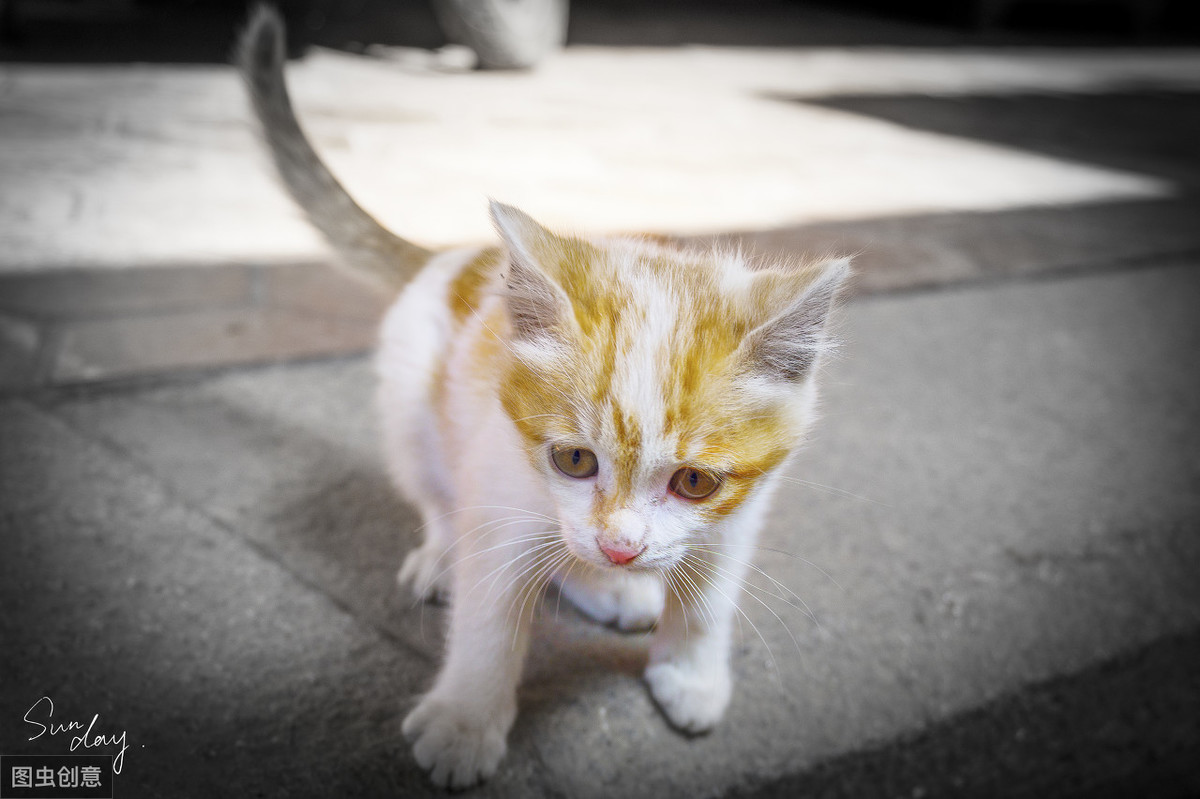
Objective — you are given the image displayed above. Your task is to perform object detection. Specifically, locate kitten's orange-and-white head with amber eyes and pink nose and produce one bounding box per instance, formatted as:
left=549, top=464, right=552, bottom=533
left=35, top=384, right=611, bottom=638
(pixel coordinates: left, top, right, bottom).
left=492, top=204, right=848, bottom=570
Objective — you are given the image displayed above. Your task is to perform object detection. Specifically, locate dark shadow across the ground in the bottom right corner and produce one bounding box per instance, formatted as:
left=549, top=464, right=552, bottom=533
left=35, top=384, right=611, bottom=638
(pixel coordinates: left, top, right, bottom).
left=738, top=631, right=1200, bottom=799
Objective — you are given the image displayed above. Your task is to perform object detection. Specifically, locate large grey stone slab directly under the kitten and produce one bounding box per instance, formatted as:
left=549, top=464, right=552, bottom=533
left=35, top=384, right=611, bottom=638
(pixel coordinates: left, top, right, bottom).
left=53, top=265, right=1200, bottom=797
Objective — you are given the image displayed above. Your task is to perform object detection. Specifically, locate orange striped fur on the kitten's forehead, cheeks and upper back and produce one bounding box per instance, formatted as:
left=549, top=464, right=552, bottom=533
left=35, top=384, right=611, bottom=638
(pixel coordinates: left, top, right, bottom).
left=446, top=205, right=849, bottom=525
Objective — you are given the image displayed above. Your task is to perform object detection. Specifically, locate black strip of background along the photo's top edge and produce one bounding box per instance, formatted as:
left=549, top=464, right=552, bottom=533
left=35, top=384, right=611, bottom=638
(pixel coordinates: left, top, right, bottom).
left=5, top=0, right=1200, bottom=64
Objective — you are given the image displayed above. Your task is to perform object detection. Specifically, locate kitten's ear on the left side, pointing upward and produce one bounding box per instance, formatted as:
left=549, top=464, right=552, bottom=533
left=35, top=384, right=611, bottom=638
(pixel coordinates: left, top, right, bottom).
left=491, top=200, right=571, bottom=344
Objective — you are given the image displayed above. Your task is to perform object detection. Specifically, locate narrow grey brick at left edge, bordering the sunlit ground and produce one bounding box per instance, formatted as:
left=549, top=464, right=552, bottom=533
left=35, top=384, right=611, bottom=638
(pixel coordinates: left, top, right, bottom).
left=0, top=264, right=253, bottom=319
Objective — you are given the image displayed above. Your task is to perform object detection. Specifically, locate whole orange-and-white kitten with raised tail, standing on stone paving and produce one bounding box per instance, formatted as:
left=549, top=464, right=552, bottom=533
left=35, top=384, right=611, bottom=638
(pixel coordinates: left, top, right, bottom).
left=239, top=7, right=848, bottom=787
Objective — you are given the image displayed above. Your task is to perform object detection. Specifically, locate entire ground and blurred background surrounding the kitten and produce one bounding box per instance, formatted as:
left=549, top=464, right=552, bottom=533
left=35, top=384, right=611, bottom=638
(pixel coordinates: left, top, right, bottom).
left=0, top=0, right=1200, bottom=798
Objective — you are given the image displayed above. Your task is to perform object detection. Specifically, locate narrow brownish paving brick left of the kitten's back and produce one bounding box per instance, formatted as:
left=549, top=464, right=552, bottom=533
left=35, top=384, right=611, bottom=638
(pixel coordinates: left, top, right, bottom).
left=50, top=308, right=376, bottom=382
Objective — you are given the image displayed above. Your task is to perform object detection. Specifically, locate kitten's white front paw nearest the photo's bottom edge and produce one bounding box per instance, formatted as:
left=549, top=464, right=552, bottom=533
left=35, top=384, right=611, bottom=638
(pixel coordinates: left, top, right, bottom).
left=401, top=693, right=516, bottom=788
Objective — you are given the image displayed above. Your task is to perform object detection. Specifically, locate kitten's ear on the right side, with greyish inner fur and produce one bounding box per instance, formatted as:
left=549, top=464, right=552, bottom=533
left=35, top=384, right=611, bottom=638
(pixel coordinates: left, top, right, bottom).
left=740, top=258, right=850, bottom=383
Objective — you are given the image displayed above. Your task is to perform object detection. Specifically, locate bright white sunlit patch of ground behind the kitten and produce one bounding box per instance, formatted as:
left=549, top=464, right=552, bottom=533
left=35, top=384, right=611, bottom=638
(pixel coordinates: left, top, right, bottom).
left=0, top=47, right=1200, bottom=270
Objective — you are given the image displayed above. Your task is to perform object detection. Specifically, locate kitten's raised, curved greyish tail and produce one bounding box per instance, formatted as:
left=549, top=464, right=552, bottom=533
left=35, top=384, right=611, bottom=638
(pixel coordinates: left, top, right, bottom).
left=235, top=4, right=432, bottom=290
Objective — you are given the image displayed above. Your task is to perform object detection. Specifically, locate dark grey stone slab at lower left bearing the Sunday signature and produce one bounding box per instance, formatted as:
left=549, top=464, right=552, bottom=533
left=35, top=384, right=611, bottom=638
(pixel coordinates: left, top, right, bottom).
left=0, top=402, right=546, bottom=799
